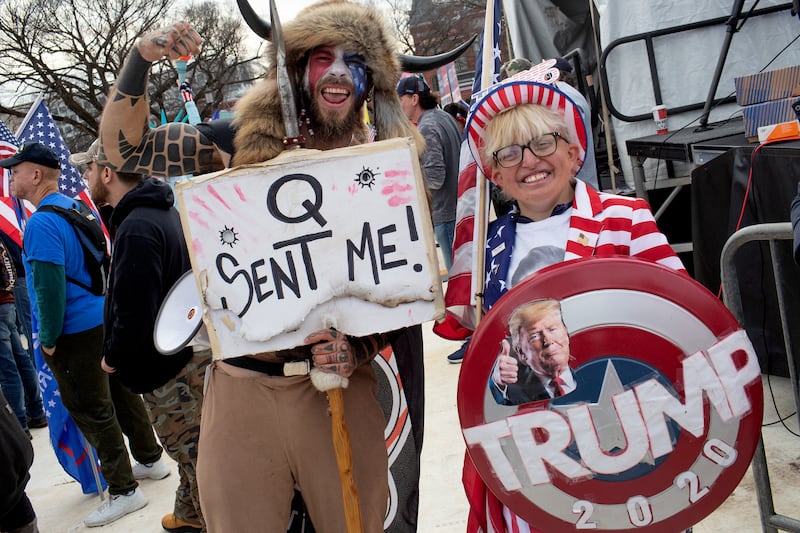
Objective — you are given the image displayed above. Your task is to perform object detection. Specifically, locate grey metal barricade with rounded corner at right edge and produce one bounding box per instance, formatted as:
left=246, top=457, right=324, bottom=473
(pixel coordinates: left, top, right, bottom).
left=720, top=222, right=800, bottom=533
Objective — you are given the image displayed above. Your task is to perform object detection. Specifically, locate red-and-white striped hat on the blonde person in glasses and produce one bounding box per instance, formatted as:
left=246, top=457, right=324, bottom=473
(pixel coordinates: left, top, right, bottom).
left=466, top=64, right=586, bottom=176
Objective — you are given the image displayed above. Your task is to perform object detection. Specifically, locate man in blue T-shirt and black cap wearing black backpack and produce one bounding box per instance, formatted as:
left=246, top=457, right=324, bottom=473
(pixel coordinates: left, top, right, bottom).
left=9, top=138, right=169, bottom=527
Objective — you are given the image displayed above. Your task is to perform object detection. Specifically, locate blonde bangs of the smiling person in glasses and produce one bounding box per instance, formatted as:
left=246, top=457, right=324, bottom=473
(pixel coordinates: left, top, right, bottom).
left=481, top=104, right=575, bottom=169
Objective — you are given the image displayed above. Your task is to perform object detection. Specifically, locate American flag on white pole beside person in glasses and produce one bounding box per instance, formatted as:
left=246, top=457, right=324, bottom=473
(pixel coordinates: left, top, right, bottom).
left=433, top=0, right=500, bottom=340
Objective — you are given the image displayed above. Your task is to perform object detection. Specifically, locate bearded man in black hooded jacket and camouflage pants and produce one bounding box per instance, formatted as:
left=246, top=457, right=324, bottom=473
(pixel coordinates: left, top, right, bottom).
left=70, top=142, right=211, bottom=532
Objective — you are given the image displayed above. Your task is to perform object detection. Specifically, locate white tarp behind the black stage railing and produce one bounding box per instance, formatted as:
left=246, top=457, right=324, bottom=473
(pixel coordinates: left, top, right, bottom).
left=504, top=0, right=800, bottom=186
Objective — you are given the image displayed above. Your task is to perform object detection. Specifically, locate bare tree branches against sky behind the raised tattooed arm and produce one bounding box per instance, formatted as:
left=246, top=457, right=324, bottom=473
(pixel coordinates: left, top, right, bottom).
left=0, top=0, right=254, bottom=146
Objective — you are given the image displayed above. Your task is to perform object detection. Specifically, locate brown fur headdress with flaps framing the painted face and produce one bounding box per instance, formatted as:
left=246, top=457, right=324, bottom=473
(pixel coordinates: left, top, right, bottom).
left=234, top=0, right=424, bottom=165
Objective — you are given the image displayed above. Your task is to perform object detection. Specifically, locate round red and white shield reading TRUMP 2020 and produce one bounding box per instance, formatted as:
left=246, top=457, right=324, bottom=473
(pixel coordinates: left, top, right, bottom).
left=458, top=258, right=763, bottom=533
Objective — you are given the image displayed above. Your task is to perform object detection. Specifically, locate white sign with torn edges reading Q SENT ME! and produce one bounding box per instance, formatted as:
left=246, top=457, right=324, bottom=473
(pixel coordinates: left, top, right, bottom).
left=176, top=139, right=444, bottom=358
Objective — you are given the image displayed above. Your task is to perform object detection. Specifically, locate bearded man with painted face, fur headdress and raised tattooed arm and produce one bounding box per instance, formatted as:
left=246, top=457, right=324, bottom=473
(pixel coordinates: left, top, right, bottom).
left=100, top=1, right=468, bottom=533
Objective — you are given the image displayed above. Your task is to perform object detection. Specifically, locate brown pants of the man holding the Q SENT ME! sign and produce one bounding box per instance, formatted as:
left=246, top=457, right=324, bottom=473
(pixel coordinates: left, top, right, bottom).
left=197, top=361, right=389, bottom=533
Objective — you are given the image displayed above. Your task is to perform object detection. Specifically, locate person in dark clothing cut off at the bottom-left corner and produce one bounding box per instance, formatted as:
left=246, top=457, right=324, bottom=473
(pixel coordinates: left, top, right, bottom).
left=0, top=386, right=39, bottom=533
